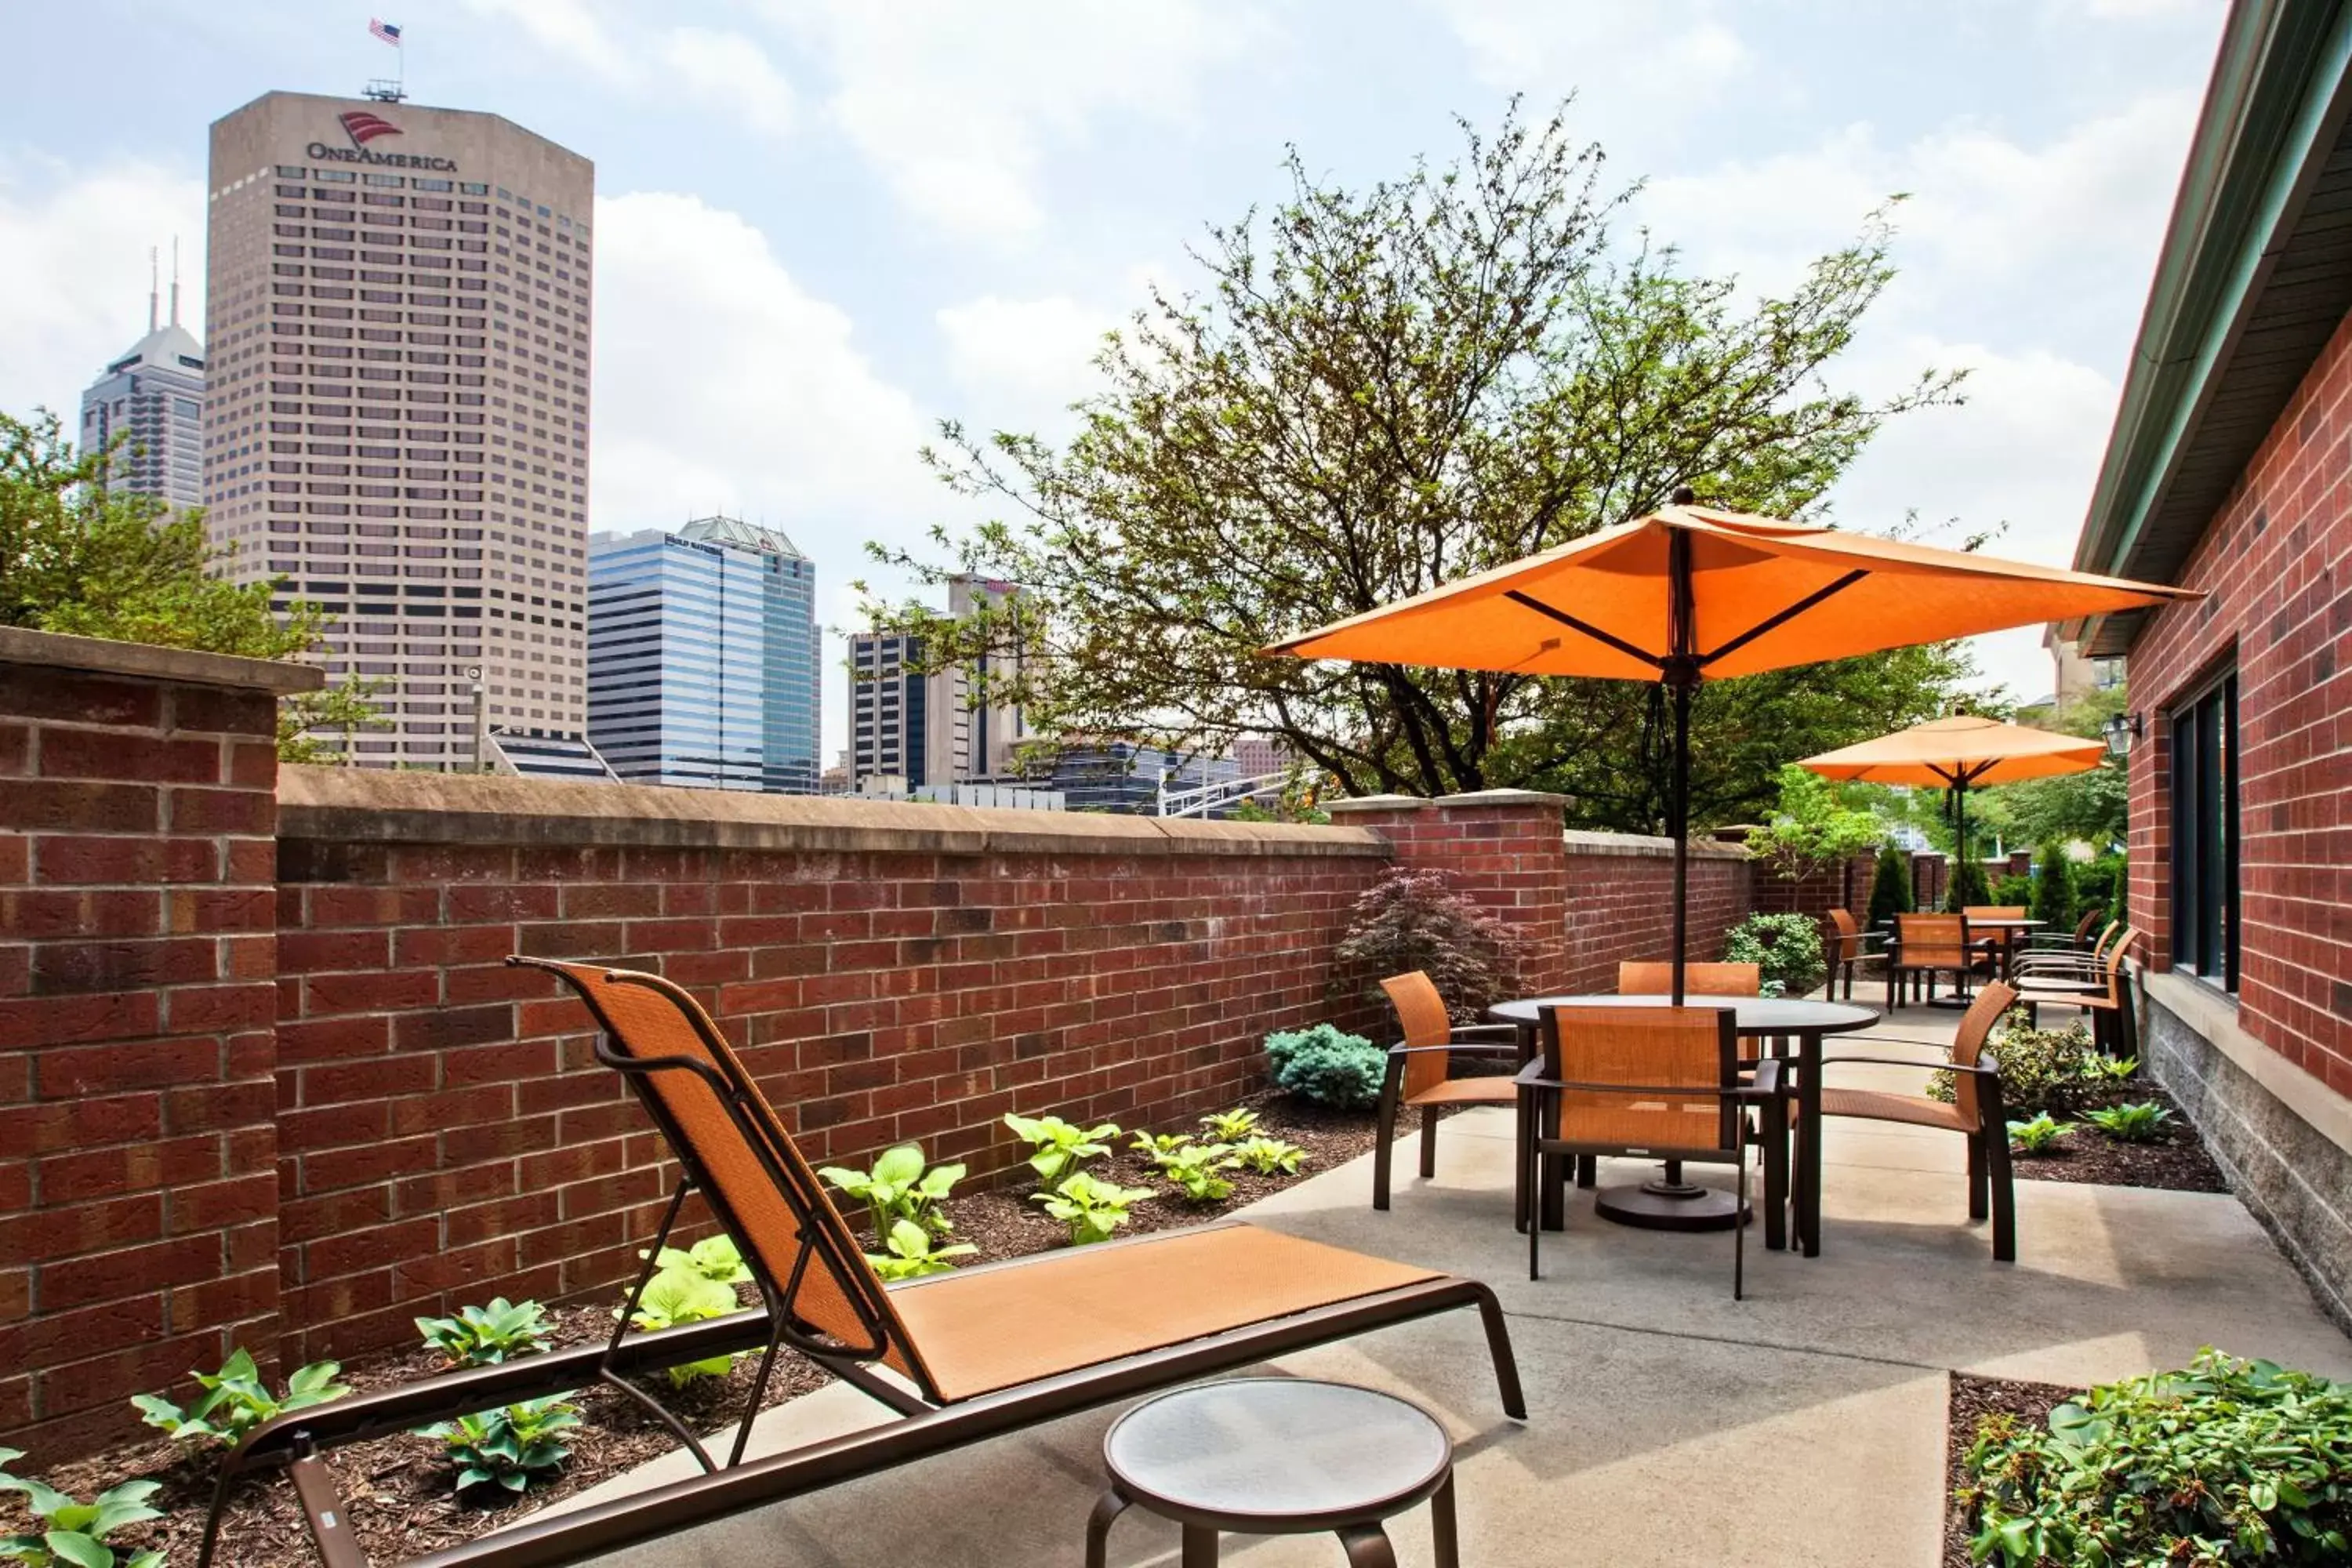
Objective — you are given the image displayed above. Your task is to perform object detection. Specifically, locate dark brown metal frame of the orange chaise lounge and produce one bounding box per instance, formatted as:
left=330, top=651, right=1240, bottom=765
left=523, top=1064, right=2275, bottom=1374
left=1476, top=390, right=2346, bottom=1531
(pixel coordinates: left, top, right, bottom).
left=198, top=956, right=1526, bottom=1568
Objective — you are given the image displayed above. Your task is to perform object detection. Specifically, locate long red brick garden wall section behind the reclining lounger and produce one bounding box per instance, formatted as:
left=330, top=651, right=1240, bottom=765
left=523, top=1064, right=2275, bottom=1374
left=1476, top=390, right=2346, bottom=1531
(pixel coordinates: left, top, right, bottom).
left=278, top=769, right=1388, bottom=1359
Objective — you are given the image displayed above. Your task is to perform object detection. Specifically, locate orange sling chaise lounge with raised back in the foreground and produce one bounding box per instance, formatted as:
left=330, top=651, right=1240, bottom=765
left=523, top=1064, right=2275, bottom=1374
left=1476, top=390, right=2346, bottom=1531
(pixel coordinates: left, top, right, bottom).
left=198, top=956, right=1526, bottom=1568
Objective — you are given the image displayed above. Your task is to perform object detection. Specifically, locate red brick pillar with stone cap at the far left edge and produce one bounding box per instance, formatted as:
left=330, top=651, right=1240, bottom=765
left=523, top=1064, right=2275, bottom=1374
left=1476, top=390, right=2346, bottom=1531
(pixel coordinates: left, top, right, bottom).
left=0, top=628, right=322, bottom=1469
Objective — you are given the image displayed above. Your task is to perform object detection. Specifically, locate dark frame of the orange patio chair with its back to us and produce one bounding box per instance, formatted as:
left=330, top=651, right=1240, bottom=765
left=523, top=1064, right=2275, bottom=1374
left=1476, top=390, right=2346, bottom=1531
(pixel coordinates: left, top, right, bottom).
left=1515, top=1008, right=1788, bottom=1300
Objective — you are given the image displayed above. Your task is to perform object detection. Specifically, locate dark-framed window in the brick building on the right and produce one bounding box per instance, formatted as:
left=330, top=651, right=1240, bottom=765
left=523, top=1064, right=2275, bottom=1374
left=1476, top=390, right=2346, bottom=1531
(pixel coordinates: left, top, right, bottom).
left=2166, top=670, right=2239, bottom=992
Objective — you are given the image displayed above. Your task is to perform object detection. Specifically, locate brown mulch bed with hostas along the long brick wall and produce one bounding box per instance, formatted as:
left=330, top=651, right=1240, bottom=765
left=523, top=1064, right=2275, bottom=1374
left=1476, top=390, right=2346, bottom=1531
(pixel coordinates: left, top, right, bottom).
left=0, top=1098, right=1418, bottom=1568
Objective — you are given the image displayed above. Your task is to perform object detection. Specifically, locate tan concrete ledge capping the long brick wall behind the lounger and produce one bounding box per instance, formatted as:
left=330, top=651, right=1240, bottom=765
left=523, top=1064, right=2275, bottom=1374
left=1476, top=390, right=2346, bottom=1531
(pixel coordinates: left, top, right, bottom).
left=278, top=767, right=1390, bottom=858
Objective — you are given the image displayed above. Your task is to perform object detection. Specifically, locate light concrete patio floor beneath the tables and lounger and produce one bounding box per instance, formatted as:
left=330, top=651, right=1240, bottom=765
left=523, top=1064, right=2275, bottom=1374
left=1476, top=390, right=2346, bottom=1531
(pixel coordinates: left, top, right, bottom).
left=539, top=1008, right=2352, bottom=1568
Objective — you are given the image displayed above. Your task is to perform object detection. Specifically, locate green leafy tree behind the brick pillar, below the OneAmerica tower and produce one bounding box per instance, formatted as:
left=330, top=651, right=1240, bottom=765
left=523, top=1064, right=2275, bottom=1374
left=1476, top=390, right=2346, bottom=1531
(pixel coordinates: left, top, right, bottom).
left=0, top=412, right=374, bottom=762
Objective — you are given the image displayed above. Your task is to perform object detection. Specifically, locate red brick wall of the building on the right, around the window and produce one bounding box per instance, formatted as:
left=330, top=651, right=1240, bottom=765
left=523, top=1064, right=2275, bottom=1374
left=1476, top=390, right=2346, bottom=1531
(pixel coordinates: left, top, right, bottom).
left=2131, top=320, right=2352, bottom=1093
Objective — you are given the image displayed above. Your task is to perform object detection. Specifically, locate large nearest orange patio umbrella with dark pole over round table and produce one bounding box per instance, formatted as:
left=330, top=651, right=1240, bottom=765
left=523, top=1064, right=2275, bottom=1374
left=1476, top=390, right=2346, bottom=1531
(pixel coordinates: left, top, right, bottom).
left=1263, top=492, right=2201, bottom=1001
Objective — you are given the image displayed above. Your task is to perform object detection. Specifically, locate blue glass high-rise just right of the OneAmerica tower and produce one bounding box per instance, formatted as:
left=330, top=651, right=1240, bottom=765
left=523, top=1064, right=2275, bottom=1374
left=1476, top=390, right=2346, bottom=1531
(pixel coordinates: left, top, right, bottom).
left=588, top=517, right=823, bottom=794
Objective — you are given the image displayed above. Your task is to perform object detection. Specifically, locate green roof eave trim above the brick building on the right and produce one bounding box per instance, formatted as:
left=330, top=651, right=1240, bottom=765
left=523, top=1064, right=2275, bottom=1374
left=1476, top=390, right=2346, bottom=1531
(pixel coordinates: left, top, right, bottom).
left=2065, top=0, right=2352, bottom=652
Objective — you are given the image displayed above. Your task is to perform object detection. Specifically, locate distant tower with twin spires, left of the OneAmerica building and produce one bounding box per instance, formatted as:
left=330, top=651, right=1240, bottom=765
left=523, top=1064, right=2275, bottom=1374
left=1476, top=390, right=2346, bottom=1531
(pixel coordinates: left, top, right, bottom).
left=80, top=240, right=205, bottom=508
